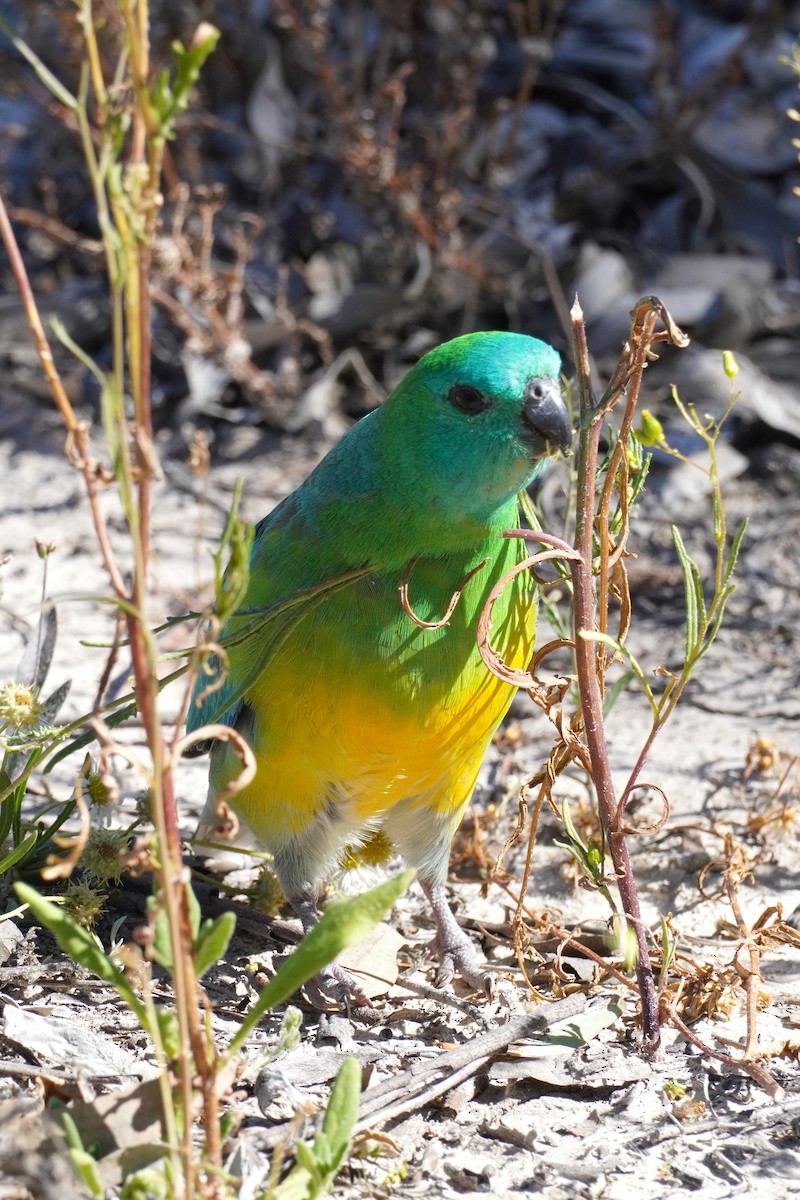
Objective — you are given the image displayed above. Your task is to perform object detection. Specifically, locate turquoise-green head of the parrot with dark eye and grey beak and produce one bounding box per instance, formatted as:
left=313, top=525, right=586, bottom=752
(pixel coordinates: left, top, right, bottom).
left=380, top=332, right=572, bottom=520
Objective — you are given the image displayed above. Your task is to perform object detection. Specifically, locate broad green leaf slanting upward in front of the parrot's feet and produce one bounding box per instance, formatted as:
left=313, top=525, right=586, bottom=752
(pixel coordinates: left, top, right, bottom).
left=224, top=871, right=414, bottom=1058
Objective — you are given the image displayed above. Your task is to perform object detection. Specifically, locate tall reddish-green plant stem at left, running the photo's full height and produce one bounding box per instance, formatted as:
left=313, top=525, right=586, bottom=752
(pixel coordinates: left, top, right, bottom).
left=0, top=7, right=227, bottom=1200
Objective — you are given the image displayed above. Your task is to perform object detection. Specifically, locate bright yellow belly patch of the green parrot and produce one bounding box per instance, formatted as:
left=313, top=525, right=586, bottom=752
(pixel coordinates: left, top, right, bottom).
left=235, top=638, right=511, bottom=846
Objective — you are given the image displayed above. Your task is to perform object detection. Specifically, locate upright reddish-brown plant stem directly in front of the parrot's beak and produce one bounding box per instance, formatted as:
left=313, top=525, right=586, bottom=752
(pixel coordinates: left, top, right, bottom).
left=571, top=300, right=660, bottom=1049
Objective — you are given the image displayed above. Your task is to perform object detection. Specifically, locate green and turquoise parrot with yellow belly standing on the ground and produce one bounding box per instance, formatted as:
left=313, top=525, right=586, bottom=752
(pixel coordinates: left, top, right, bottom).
left=187, top=331, right=572, bottom=1010
